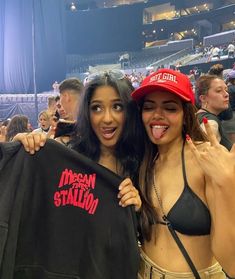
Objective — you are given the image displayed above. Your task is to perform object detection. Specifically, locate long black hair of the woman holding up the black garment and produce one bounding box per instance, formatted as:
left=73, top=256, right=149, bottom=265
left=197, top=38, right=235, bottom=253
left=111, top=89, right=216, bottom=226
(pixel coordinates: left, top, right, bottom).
left=72, top=74, right=144, bottom=180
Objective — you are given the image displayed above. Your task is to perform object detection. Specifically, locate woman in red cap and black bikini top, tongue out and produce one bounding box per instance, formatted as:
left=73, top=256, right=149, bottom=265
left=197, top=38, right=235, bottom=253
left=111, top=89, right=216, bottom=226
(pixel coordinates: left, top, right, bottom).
left=132, top=69, right=235, bottom=279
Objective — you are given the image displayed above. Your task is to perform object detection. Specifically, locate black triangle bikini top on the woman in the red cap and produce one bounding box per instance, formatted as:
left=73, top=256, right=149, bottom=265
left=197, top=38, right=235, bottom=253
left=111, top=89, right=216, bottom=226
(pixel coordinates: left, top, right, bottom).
left=160, top=142, right=211, bottom=235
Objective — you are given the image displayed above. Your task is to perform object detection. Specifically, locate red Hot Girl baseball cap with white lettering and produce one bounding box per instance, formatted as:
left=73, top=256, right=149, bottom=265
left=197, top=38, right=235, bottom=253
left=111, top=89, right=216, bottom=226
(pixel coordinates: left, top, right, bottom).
left=131, top=69, right=195, bottom=104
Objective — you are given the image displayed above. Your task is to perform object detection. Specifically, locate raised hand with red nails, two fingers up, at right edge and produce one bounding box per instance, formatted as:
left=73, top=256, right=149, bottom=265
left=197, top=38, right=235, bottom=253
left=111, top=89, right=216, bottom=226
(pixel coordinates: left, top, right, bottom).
left=186, top=118, right=235, bottom=186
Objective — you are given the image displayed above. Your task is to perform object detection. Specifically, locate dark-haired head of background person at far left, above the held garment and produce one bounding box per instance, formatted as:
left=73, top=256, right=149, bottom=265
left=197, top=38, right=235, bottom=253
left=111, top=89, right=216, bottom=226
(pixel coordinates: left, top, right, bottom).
left=5, top=114, right=32, bottom=142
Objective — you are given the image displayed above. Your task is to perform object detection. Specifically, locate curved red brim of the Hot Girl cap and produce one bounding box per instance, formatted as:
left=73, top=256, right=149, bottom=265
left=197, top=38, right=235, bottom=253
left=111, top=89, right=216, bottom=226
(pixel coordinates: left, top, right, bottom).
left=131, top=84, right=191, bottom=102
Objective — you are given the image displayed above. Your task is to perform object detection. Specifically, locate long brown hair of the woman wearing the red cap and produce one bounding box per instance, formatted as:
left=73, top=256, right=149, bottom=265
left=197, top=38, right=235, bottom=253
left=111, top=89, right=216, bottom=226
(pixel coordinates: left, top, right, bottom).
left=139, top=102, right=207, bottom=241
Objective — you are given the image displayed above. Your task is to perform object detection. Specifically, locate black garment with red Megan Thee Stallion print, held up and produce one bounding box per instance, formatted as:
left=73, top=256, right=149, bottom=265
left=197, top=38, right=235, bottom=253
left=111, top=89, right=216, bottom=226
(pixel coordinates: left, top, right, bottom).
left=0, top=140, right=139, bottom=279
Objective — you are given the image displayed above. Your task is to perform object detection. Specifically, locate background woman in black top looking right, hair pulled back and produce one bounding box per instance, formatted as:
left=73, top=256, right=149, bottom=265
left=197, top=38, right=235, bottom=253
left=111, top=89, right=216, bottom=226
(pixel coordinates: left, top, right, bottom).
left=195, top=75, right=232, bottom=150
